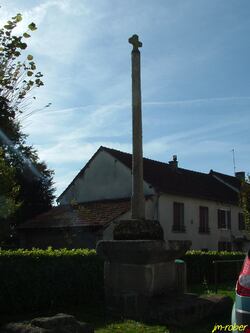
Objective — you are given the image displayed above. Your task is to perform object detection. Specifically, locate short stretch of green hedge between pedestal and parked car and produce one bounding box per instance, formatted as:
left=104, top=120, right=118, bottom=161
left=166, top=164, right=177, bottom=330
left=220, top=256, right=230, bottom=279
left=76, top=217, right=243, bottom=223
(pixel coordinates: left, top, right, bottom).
left=182, top=251, right=246, bottom=284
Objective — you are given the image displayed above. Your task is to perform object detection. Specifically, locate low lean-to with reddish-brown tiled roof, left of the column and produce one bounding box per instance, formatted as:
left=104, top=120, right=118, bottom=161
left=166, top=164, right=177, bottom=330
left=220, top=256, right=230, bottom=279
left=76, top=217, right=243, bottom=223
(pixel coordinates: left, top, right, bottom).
left=19, top=199, right=130, bottom=248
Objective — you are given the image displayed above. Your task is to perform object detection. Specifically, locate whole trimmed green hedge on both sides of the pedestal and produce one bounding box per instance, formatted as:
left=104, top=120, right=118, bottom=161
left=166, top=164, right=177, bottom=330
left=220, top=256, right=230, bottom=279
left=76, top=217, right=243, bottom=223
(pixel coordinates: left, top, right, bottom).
left=0, top=249, right=245, bottom=314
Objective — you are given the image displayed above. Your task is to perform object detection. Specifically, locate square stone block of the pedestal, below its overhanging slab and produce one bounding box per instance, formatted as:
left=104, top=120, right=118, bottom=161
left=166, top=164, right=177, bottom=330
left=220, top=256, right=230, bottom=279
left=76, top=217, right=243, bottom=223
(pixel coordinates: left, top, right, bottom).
left=104, top=261, right=175, bottom=319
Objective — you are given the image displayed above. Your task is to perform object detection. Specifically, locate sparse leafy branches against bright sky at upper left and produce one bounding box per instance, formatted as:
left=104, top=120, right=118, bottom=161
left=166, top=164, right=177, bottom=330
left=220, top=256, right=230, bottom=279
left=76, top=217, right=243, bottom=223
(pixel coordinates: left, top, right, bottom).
left=0, top=14, right=43, bottom=112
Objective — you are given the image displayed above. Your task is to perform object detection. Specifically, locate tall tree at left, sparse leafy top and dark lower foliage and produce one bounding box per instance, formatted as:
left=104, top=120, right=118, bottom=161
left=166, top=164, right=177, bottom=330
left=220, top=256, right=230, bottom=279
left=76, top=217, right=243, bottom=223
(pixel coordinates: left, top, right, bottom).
left=0, top=14, right=54, bottom=241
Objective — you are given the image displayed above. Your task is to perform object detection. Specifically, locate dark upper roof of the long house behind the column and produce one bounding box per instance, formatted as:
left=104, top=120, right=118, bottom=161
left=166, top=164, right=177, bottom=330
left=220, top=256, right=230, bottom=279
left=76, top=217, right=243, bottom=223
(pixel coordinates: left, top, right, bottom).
left=101, top=147, right=239, bottom=204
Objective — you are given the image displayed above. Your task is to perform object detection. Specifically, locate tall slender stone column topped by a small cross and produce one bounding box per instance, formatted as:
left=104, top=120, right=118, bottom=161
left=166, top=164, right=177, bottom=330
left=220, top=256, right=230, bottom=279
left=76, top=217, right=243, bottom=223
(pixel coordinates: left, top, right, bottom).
left=128, top=35, right=145, bottom=219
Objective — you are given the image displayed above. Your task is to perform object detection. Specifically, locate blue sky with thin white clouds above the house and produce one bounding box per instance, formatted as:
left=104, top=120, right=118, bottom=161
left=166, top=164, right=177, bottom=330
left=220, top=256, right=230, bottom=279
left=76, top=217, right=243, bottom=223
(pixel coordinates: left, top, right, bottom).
left=0, top=0, right=250, bottom=194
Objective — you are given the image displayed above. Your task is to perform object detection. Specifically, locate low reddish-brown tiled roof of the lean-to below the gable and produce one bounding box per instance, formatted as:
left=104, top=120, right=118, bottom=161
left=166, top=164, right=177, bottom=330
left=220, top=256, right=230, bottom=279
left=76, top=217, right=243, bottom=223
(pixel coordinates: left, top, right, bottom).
left=19, top=199, right=130, bottom=229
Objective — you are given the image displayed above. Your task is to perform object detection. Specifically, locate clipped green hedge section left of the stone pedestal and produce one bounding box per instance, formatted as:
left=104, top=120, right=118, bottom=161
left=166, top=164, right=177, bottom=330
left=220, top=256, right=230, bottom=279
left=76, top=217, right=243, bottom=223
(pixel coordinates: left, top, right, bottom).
left=0, top=249, right=104, bottom=313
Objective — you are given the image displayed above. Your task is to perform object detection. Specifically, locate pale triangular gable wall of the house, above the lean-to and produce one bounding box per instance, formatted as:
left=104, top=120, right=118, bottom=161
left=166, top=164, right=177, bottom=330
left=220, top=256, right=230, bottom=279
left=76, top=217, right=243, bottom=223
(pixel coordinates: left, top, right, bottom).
left=58, top=151, right=154, bottom=205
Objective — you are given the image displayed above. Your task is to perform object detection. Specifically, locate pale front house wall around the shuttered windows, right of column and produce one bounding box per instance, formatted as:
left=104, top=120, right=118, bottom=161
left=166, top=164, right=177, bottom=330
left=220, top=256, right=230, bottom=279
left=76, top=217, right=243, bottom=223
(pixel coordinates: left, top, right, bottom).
left=158, top=194, right=243, bottom=250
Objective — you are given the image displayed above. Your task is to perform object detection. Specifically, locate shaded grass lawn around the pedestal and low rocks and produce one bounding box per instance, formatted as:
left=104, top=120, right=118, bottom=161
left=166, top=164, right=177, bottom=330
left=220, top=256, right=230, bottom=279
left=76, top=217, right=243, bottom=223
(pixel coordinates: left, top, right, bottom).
left=0, top=283, right=235, bottom=333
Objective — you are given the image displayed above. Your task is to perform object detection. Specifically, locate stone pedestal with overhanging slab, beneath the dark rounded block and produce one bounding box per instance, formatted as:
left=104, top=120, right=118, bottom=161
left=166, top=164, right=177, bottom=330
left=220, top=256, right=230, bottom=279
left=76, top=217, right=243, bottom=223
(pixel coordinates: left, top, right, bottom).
left=97, top=240, right=186, bottom=320
